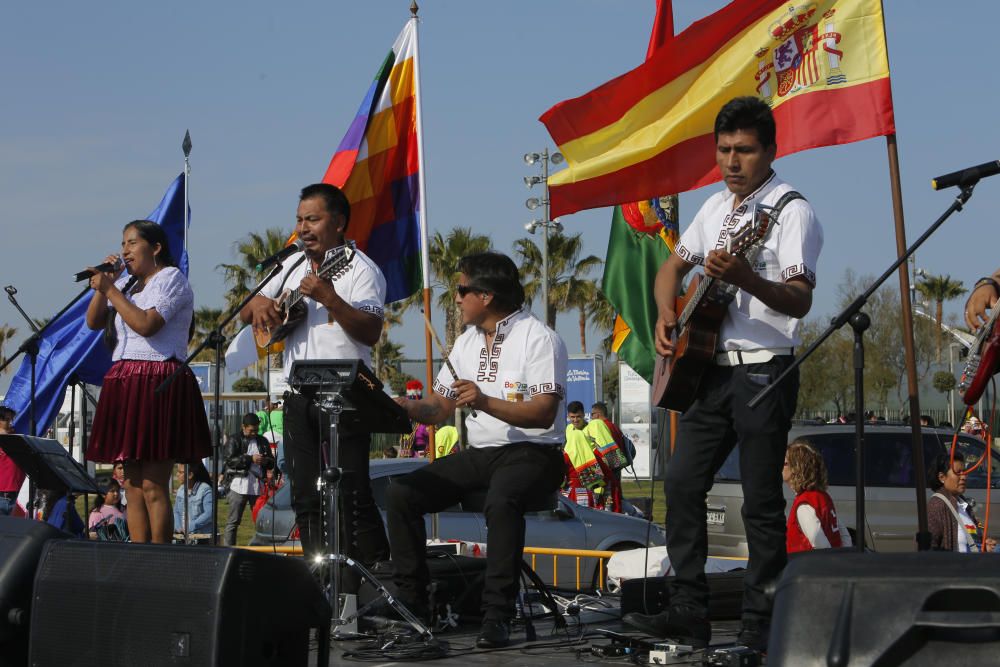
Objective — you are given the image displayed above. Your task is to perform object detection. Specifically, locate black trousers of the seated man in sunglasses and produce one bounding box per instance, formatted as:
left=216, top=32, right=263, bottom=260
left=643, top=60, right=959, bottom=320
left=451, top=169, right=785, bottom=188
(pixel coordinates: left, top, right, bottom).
left=386, top=442, right=565, bottom=620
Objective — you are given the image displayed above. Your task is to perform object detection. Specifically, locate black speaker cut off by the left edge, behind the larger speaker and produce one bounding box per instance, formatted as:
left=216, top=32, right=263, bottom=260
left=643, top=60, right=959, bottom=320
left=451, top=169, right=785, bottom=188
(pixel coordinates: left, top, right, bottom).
left=0, top=516, right=69, bottom=667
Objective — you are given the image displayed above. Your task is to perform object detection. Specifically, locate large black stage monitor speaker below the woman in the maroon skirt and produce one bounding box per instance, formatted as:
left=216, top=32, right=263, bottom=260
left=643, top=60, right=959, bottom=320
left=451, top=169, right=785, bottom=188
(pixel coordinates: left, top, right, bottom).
left=30, top=540, right=331, bottom=667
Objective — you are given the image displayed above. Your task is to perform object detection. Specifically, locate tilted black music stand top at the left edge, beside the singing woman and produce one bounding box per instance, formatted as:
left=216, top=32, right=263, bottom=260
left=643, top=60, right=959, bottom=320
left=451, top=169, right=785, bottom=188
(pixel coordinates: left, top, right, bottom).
left=0, top=434, right=101, bottom=493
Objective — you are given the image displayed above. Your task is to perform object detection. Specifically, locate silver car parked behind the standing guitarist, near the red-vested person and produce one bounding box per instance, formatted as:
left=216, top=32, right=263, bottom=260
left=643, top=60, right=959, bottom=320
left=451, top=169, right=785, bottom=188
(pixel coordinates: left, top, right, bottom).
left=708, top=424, right=1000, bottom=557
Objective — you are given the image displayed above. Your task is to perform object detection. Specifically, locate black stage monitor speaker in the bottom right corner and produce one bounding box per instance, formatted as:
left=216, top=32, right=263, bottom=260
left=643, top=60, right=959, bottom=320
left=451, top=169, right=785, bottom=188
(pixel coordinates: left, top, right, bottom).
left=768, top=551, right=1000, bottom=667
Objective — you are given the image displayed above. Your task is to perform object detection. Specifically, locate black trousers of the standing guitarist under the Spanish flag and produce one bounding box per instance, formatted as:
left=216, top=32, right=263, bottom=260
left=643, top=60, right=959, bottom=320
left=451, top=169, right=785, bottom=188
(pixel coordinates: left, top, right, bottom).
left=663, top=356, right=799, bottom=621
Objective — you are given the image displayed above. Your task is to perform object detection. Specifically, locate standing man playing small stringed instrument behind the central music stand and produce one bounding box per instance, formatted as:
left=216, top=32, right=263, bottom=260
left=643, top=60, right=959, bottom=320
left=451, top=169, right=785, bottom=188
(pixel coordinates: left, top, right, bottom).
left=240, top=183, right=389, bottom=565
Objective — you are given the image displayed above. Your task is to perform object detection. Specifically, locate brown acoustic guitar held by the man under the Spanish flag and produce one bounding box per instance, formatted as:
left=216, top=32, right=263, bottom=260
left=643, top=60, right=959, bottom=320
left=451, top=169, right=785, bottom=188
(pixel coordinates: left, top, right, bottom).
left=653, top=204, right=777, bottom=412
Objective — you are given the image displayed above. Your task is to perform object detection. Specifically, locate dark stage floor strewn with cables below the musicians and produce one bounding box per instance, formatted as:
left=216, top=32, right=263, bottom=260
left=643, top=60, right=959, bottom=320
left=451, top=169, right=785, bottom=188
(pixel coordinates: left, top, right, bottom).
left=310, top=597, right=752, bottom=667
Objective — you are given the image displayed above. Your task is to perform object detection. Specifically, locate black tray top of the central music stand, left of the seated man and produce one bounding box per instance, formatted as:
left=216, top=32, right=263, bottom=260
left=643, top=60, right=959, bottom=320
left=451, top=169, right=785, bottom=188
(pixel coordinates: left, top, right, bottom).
left=288, top=359, right=413, bottom=433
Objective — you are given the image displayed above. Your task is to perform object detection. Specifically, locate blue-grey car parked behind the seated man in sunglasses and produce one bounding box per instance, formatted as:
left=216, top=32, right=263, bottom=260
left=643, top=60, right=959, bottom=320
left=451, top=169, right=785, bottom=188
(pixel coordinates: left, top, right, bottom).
left=250, top=458, right=665, bottom=587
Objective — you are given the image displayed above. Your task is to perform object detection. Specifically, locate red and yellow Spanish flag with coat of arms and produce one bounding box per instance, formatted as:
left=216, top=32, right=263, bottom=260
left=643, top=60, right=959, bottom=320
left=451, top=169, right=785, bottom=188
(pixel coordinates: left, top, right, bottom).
left=540, top=0, right=895, bottom=217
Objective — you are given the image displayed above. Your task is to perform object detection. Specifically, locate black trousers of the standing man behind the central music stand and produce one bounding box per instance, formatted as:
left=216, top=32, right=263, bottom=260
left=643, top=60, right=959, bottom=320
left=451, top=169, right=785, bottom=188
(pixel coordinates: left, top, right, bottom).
left=284, top=392, right=389, bottom=565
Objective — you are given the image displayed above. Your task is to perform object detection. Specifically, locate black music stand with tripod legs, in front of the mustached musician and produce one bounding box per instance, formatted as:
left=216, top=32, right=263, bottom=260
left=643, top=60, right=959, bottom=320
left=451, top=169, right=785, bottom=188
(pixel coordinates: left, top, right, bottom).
left=288, top=359, right=433, bottom=663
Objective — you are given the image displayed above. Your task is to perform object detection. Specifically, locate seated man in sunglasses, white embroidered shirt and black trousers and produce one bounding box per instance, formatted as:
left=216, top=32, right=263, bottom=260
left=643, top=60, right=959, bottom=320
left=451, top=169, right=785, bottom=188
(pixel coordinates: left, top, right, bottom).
left=386, top=252, right=567, bottom=648
